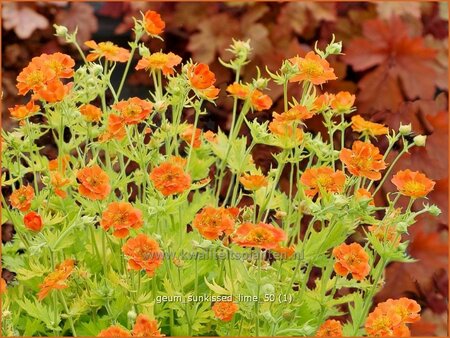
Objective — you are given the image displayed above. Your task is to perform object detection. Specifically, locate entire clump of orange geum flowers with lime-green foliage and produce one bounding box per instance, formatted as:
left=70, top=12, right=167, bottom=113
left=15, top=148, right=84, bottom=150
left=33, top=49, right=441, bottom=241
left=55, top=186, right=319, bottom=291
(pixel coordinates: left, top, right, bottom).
left=0, top=11, right=439, bottom=337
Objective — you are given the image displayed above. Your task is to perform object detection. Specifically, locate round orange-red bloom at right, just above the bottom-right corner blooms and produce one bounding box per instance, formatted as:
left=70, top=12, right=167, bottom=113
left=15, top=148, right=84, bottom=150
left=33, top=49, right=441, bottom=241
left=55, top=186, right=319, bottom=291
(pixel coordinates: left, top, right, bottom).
left=333, top=243, right=370, bottom=280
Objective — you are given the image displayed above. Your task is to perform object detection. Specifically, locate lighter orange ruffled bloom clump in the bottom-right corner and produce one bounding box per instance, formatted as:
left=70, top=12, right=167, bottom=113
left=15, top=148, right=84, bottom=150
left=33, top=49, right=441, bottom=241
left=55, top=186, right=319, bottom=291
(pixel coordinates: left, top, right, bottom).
left=365, top=297, right=420, bottom=337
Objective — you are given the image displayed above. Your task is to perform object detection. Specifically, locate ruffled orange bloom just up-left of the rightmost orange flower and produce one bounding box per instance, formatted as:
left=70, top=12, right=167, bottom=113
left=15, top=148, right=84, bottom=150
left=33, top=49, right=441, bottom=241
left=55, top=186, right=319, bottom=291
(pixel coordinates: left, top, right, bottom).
left=339, top=141, right=386, bottom=181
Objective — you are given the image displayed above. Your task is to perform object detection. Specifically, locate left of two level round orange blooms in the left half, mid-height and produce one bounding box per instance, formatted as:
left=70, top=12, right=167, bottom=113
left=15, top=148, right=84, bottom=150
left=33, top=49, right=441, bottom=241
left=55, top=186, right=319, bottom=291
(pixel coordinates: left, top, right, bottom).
left=77, top=165, right=111, bottom=200
